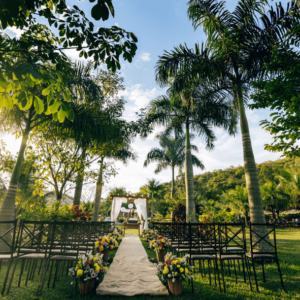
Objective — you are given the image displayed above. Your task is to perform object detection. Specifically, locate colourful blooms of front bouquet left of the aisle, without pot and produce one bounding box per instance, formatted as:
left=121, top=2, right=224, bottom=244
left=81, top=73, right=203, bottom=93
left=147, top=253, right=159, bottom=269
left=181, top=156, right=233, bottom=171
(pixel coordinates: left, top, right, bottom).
left=69, top=251, right=107, bottom=282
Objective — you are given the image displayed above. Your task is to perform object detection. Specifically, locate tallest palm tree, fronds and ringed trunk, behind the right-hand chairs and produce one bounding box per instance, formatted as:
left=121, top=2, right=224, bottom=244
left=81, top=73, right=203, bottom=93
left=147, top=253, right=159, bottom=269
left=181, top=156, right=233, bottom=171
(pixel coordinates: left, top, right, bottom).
left=157, top=0, right=293, bottom=239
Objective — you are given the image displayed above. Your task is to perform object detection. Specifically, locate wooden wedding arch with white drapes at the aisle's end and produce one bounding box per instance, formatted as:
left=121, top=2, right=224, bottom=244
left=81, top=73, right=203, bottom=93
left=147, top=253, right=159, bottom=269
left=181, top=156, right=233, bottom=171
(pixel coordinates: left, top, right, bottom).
left=111, top=195, right=150, bottom=229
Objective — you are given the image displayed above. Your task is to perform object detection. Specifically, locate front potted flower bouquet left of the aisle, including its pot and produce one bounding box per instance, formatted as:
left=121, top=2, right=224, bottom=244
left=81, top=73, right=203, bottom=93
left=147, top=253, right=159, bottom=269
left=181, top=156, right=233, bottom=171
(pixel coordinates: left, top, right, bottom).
left=69, top=251, right=107, bottom=296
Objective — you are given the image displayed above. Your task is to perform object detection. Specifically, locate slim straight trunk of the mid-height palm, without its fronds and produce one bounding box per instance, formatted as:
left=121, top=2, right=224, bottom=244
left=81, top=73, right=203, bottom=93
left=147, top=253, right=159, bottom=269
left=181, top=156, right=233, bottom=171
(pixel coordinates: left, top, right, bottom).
left=185, top=120, right=197, bottom=223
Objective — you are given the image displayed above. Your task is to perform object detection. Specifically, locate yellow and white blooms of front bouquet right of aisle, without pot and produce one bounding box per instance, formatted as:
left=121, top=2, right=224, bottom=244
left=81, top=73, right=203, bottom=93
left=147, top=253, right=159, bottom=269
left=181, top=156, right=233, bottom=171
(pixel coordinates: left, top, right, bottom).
left=157, top=252, right=194, bottom=282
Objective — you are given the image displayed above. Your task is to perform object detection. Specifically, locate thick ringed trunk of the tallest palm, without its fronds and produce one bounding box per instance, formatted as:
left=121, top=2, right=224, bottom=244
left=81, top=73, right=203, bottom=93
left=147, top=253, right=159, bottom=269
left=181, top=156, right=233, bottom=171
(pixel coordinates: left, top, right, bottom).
left=237, top=85, right=270, bottom=251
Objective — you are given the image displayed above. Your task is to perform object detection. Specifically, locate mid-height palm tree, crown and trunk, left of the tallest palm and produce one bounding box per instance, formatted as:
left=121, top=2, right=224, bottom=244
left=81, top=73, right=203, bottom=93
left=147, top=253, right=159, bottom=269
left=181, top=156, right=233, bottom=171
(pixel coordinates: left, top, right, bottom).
left=140, top=78, right=233, bottom=222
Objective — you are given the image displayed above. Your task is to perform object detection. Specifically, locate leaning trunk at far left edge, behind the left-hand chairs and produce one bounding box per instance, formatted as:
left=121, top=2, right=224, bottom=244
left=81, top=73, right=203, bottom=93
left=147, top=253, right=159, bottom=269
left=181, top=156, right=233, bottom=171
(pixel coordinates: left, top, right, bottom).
left=0, top=118, right=31, bottom=251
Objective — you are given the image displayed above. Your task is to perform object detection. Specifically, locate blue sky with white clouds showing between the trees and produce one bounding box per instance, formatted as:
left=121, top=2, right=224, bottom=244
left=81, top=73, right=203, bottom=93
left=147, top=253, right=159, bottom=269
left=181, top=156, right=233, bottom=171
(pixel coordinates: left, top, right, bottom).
left=2, top=0, right=287, bottom=196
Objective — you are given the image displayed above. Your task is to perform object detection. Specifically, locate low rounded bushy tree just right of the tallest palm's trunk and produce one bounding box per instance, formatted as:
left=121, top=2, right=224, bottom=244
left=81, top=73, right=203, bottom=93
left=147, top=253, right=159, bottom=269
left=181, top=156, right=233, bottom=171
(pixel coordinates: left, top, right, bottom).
left=261, top=181, right=290, bottom=219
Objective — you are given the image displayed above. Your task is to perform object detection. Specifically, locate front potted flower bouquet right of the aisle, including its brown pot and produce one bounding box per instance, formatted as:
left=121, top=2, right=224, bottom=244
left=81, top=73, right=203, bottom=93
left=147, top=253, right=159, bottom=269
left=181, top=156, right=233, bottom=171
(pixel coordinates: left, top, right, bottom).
left=157, top=252, right=194, bottom=295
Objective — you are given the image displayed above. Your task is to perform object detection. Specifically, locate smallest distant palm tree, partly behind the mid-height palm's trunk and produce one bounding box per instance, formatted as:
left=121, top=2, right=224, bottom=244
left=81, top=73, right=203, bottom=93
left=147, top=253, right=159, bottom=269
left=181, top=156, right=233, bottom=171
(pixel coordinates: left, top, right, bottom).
left=144, top=133, right=204, bottom=198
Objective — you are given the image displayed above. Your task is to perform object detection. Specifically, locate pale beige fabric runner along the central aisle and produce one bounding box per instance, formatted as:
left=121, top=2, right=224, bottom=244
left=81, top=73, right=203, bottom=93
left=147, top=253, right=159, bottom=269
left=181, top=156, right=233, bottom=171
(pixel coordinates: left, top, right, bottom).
left=96, top=234, right=169, bottom=296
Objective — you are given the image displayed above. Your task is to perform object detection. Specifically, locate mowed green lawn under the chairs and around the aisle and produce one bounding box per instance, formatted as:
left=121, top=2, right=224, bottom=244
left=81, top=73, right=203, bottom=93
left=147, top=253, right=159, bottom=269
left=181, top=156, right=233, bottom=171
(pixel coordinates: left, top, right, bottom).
left=0, top=229, right=300, bottom=300
